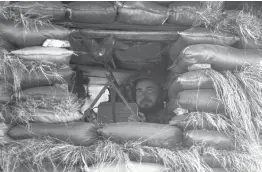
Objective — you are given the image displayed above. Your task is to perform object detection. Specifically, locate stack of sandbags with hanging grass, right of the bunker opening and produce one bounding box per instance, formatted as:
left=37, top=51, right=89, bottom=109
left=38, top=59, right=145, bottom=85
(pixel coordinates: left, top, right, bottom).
left=167, top=22, right=261, bottom=171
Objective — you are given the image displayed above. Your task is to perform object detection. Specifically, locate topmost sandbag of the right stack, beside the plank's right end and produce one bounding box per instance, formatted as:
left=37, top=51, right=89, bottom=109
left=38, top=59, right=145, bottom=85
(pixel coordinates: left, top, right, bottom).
left=169, top=27, right=240, bottom=61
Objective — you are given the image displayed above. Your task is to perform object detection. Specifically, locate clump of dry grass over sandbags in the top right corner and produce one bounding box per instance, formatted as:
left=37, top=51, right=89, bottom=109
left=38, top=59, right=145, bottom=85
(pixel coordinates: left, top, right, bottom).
left=217, top=9, right=262, bottom=49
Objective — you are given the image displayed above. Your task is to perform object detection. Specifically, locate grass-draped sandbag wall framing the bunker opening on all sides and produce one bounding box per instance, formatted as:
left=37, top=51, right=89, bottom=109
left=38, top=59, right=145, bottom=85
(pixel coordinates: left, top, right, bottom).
left=0, top=2, right=262, bottom=172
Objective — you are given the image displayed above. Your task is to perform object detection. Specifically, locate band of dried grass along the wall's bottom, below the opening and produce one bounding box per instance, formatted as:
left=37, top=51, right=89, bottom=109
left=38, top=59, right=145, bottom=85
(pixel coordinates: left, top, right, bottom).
left=0, top=138, right=262, bottom=172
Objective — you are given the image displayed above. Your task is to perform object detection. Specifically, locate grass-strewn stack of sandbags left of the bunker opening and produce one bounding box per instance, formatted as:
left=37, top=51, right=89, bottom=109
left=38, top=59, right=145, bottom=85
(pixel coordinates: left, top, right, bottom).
left=0, top=2, right=84, bottom=145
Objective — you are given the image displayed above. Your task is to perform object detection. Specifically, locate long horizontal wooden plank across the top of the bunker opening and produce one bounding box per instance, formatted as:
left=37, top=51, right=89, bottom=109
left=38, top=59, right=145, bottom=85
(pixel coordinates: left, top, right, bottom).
left=72, top=29, right=179, bottom=42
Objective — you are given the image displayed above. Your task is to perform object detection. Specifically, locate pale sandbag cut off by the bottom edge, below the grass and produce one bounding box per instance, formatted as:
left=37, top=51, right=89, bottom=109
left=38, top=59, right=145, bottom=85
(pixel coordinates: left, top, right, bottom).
left=89, top=162, right=168, bottom=172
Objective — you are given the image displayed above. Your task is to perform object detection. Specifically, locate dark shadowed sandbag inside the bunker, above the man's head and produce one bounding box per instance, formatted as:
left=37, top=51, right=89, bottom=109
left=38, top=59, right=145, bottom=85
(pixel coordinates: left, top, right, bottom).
left=114, top=43, right=162, bottom=70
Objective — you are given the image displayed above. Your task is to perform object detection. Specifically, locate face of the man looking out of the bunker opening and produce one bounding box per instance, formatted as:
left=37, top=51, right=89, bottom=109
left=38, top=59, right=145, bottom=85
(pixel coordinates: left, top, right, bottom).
left=136, top=79, right=159, bottom=110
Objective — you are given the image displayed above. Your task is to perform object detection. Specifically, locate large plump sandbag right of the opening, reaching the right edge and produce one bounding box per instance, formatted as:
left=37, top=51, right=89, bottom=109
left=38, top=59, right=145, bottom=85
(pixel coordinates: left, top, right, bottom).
left=169, top=44, right=262, bottom=73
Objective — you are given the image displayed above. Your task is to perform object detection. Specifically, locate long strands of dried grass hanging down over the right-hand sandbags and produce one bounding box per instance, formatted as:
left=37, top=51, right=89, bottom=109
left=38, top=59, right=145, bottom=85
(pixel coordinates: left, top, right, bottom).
left=205, top=66, right=262, bottom=158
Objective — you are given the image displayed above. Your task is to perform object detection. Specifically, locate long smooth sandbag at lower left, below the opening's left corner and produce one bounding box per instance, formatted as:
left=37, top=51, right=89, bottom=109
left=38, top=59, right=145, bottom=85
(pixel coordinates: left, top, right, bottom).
left=7, top=122, right=98, bottom=146
